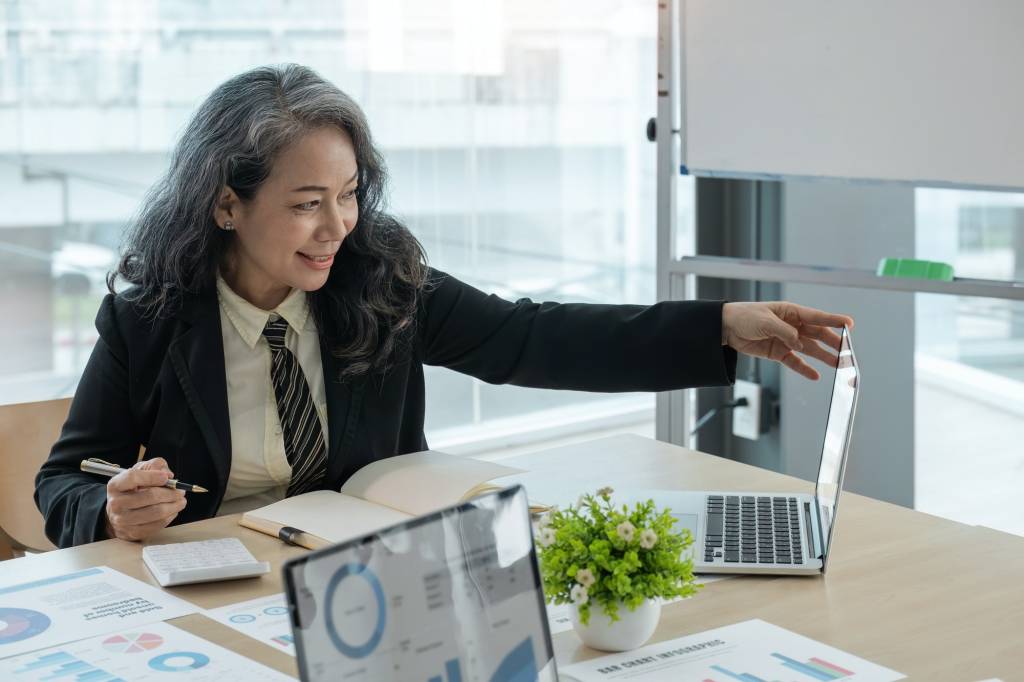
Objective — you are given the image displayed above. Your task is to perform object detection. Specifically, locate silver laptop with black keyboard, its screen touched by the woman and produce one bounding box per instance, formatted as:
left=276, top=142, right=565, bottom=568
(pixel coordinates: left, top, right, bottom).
left=637, top=328, right=860, bottom=576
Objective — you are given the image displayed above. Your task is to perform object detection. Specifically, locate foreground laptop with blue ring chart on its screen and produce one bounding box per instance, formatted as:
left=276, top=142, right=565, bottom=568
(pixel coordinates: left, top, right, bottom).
left=283, top=485, right=558, bottom=682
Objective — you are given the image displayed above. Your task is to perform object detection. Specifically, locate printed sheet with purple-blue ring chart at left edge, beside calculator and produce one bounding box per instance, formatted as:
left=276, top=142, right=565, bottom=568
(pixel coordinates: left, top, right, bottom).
left=0, top=566, right=196, bottom=658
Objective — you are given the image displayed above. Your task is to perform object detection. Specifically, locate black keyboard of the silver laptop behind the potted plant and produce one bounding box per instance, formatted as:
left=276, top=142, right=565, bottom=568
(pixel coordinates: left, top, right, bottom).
left=703, top=495, right=804, bottom=564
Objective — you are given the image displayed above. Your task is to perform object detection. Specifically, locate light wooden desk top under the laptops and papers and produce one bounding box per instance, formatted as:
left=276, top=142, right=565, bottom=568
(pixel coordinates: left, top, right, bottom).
left=0, top=436, right=1024, bottom=682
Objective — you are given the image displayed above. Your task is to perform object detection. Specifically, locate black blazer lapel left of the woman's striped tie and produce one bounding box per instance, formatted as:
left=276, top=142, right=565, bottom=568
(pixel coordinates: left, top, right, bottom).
left=169, top=291, right=231, bottom=493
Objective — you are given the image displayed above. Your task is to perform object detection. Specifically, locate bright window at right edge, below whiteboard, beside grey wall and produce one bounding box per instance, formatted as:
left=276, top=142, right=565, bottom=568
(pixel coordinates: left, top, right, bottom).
left=914, top=189, right=1024, bottom=535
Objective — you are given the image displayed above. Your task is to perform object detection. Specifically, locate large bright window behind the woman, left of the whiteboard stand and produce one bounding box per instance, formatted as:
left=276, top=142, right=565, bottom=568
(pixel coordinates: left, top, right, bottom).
left=0, top=0, right=656, bottom=445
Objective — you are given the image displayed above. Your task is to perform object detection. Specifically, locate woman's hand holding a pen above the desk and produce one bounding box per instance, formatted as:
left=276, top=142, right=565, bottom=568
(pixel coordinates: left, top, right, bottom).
left=106, top=457, right=185, bottom=542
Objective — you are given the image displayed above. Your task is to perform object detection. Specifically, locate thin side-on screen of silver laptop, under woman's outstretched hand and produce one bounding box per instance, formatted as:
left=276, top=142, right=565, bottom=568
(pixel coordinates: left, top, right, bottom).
left=814, top=328, right=860, bottom=557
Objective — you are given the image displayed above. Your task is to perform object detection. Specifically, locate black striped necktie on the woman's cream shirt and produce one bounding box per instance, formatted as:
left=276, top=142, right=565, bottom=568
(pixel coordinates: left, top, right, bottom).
left=263, top=318, right=327, bottom=497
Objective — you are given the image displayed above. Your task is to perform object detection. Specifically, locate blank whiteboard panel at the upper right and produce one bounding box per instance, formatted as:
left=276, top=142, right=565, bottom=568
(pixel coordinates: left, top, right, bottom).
left=679, top=0, right=1024, bottom=187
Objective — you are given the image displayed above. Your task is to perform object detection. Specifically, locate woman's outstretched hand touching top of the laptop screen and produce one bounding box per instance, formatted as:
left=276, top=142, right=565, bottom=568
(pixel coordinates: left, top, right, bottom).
left=722, top=301, right=853, bottom=381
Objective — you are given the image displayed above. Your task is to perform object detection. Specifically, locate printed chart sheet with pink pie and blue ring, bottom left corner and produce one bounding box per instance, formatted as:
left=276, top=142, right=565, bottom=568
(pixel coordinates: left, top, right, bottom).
left=0, top=623, right=294, bottom=682
